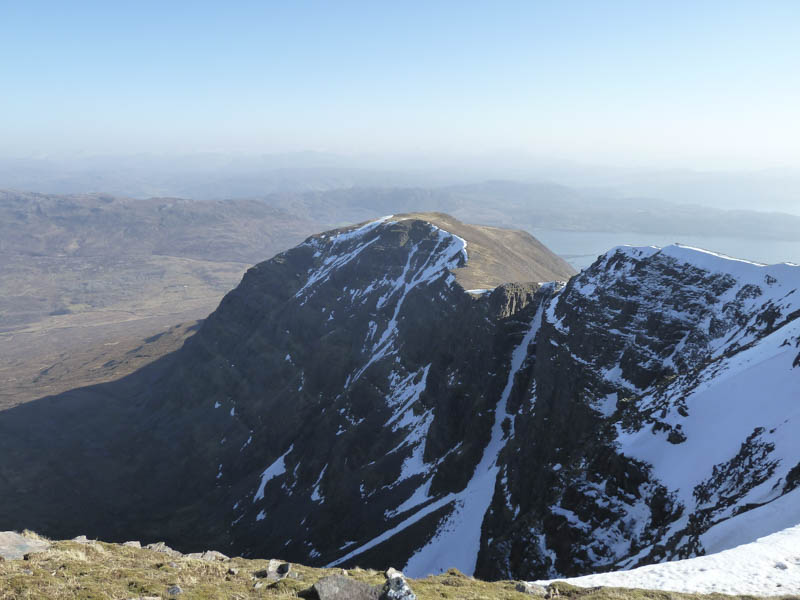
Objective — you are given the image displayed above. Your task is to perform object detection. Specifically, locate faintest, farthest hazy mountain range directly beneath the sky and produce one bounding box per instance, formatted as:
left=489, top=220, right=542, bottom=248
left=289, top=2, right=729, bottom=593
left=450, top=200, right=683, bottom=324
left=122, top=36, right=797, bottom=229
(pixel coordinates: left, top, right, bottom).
left=0, top=152, right=800, bottom=216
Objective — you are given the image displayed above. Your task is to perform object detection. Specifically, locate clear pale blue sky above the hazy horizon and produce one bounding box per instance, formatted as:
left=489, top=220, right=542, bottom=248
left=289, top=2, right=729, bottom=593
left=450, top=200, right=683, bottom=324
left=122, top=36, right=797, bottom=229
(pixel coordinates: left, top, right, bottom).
left=0, top=0, right=800, bottom=168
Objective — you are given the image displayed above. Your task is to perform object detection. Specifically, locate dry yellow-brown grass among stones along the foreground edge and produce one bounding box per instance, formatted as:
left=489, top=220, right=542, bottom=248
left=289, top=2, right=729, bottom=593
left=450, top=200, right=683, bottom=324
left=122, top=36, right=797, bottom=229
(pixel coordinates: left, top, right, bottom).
left=0, top=533, right=788, bottom=600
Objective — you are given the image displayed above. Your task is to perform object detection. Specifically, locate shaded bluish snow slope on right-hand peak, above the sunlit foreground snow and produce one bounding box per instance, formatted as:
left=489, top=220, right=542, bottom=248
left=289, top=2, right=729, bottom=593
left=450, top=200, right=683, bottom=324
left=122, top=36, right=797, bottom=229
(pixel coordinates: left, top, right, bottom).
left=604, top=246, right=800, bottom=564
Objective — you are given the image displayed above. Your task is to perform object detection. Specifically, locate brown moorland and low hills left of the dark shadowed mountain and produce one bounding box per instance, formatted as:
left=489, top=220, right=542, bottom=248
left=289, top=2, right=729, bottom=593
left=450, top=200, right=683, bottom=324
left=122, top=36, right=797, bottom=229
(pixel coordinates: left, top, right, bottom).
left=0, top=191, right=328, bottom=408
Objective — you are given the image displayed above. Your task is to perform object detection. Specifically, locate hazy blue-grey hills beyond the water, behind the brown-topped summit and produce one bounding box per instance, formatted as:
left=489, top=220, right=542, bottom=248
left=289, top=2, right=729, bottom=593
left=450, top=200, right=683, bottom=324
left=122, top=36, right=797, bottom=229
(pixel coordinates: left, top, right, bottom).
left=264, top=181, right=800, bottom=242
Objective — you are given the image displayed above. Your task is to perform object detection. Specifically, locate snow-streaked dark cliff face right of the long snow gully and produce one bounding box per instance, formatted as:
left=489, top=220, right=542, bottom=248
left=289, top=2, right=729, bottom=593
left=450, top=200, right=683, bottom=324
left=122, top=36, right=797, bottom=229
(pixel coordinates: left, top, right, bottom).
left=480, top=246, right=800, bottom=577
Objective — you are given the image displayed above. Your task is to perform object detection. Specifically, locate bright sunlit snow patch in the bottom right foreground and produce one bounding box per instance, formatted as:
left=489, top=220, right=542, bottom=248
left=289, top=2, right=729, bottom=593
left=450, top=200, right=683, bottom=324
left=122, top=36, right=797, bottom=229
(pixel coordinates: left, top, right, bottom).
left=536, top=516, right=800, bottom=596
